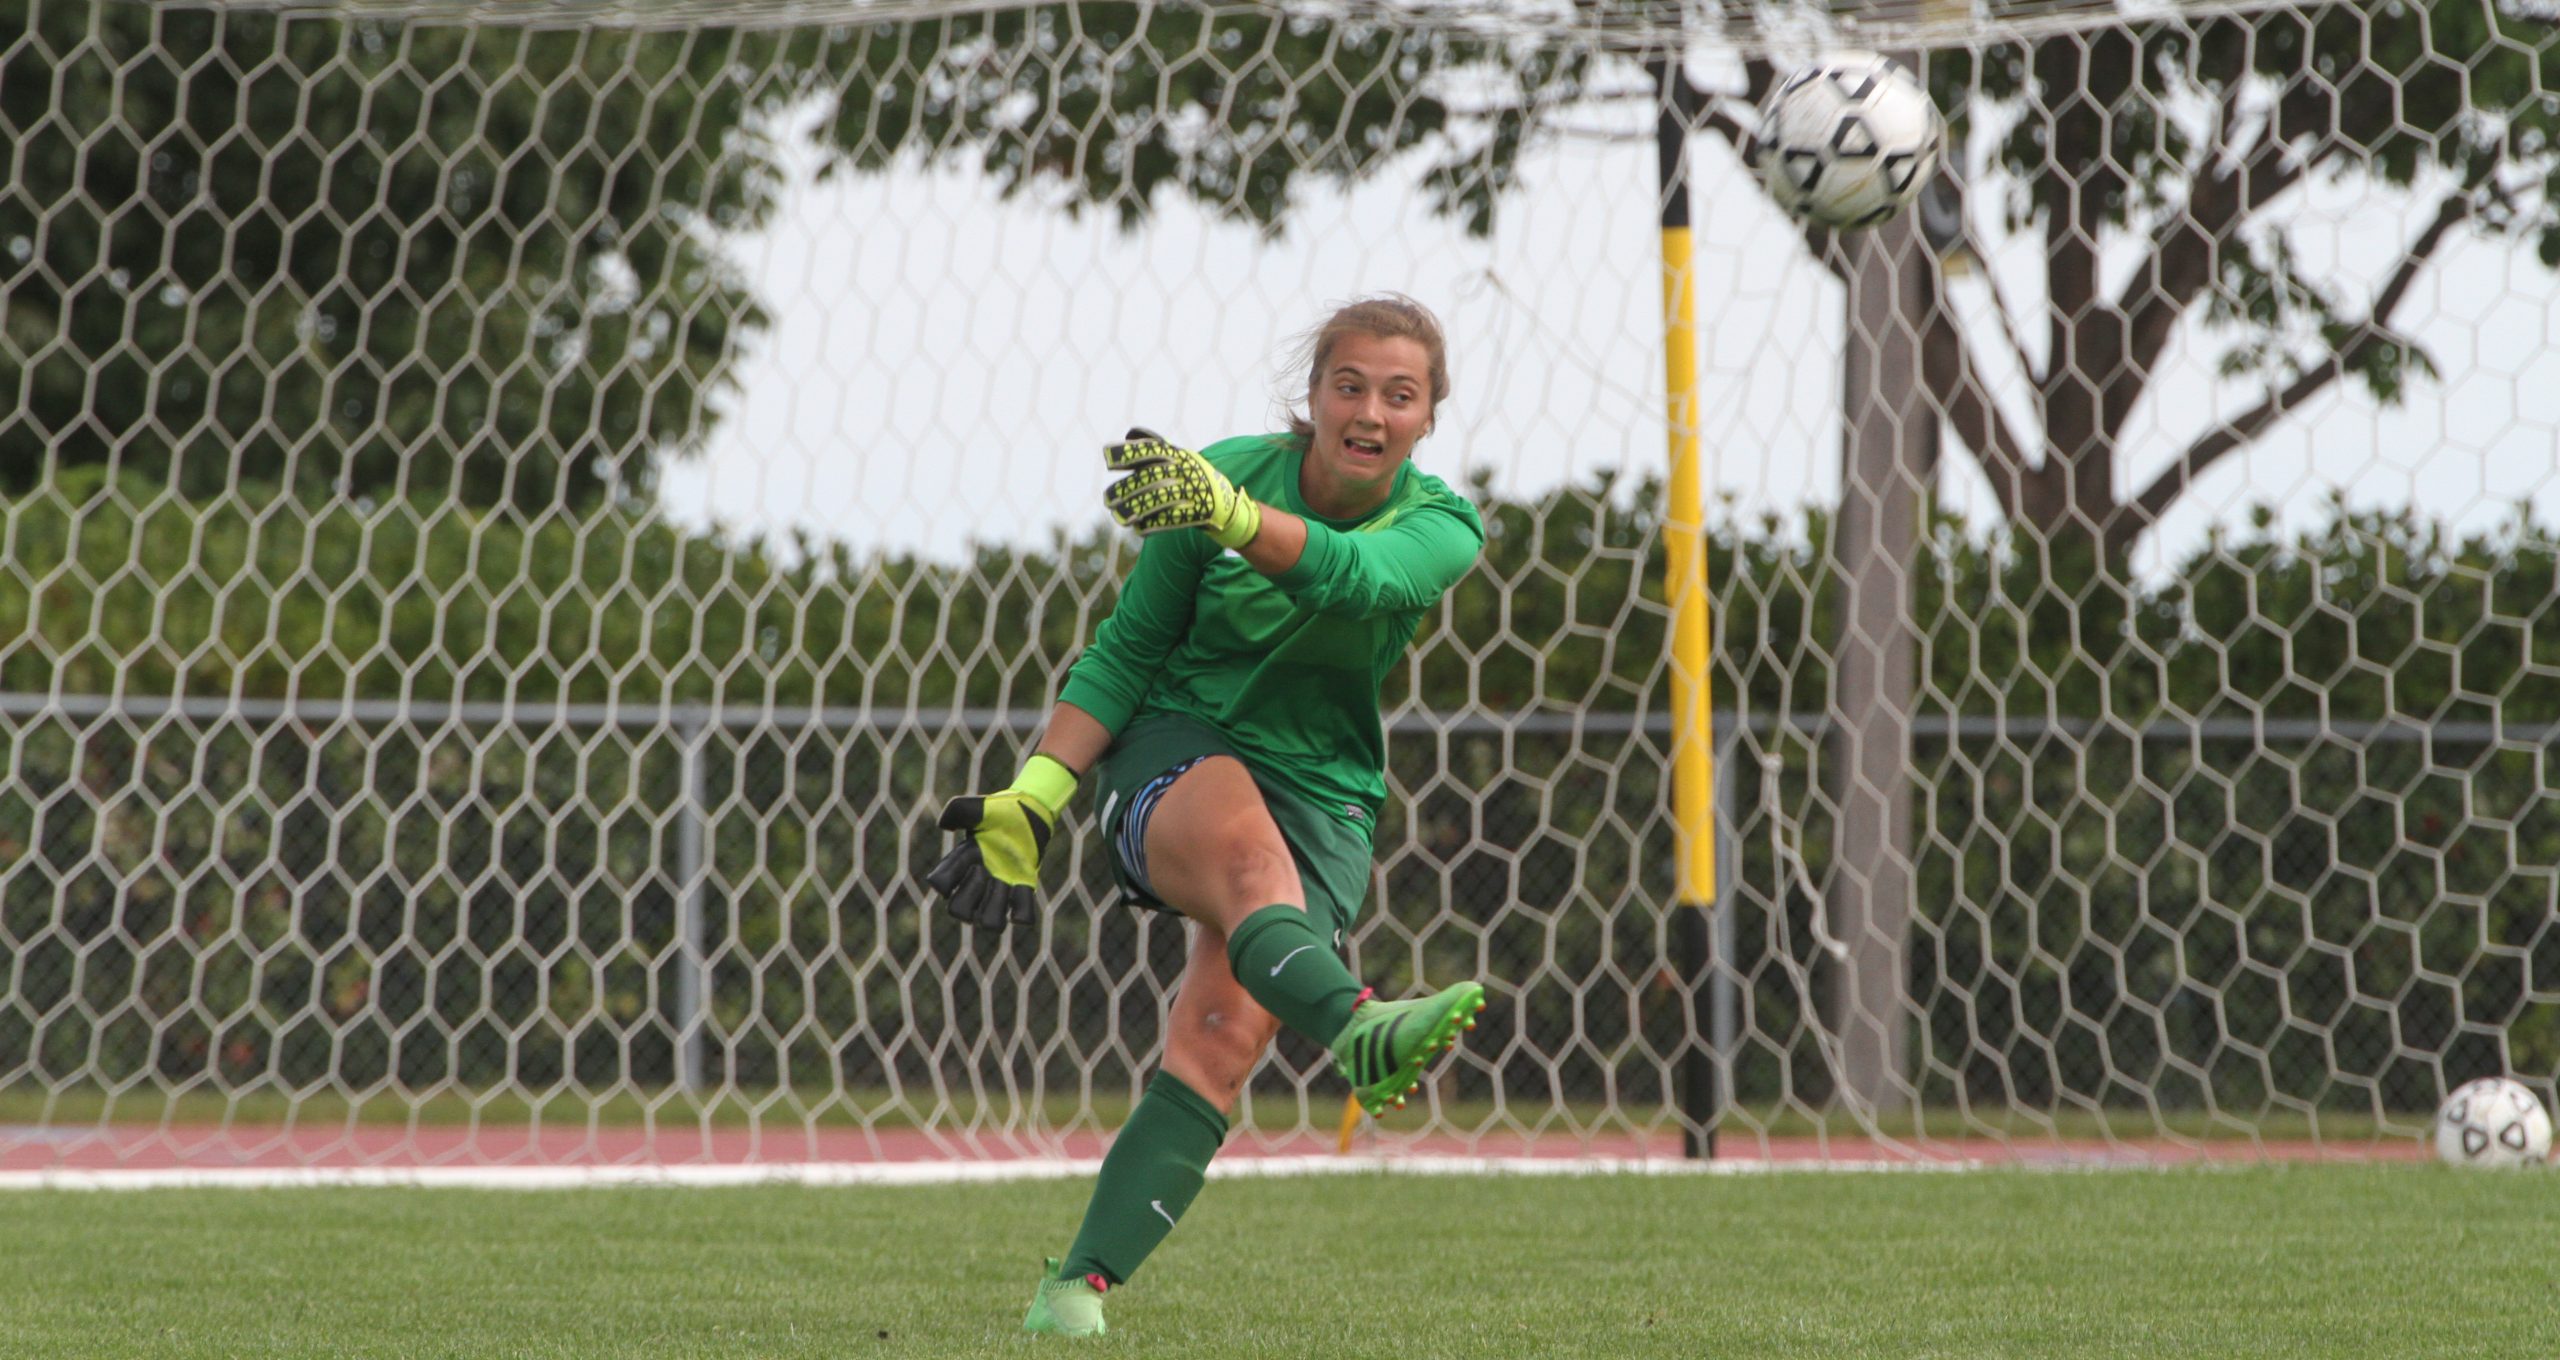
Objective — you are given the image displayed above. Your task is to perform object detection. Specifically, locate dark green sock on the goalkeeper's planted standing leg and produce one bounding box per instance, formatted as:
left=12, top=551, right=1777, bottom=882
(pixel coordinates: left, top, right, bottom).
left=1057, top=1071, right=1226, bottom=1283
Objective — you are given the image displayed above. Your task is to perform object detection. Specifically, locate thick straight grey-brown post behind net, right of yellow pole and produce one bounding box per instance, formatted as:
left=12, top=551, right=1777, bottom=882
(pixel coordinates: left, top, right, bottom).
left=1823, top=213, right=1938, bottom=1112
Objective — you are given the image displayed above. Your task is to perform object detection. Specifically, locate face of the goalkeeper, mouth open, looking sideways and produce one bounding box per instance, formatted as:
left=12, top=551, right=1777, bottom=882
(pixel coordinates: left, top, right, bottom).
left=1298, top=333, right=1431, bottom=517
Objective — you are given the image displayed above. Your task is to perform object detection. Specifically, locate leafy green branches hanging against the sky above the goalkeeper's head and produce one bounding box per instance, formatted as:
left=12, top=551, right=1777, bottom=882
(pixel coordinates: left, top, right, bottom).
left=814, top=0, right=1608, bottom=233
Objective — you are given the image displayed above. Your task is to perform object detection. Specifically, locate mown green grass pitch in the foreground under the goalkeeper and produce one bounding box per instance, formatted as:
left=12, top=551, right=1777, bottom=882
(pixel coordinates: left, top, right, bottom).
left=0, top=1165, right=2560, bottom=1360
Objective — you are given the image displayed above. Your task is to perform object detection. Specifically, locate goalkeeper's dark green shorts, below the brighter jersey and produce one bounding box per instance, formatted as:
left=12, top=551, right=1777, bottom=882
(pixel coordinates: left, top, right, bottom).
left=1096, top=715, right=1375, bottom=948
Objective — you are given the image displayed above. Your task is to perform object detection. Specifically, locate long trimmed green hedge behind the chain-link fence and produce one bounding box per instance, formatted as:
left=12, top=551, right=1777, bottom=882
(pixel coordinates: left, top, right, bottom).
left=0, top=474, right=2560, bottom=1112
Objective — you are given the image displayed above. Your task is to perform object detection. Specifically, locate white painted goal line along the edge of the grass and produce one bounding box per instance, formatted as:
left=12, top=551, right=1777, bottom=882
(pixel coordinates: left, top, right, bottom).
left=0, top=1155, right=1992, bottom=1191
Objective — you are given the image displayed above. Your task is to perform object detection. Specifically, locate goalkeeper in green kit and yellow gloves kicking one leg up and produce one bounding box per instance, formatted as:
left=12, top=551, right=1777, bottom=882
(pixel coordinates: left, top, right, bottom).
left=927, top=297, right=1485, bottom=1337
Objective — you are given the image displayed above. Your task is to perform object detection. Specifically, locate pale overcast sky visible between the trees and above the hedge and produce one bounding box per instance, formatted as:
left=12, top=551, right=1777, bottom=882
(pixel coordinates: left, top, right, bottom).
left=663, top=87, right=2560, bottom=583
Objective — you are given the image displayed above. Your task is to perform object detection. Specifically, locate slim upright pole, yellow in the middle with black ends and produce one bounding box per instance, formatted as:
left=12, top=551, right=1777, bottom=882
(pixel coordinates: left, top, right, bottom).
left=1654, top=49, right=1715, bottom=1158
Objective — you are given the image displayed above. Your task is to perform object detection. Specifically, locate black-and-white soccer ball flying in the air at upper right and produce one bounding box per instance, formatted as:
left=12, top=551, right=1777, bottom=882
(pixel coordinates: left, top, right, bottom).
left=1751, top=51, right=1946, bottom=228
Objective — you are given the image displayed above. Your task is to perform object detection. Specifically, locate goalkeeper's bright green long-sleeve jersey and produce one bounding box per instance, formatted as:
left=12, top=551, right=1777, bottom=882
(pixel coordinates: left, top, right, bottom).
left=1060, top=435, right=1485, bottom=830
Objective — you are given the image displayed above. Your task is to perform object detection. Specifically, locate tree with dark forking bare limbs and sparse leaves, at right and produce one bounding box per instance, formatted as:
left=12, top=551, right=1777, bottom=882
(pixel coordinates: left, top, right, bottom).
left=1925, top=0, right=2560, bottom=574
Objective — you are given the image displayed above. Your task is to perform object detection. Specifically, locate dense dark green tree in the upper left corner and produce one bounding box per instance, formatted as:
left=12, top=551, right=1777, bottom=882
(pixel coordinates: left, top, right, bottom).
left=0, top=0, right=786, bottom=507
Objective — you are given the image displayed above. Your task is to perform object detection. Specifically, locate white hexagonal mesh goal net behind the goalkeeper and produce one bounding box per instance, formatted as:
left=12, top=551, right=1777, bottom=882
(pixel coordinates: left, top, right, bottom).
left=0, top=0, right=2560, bottom=1165
